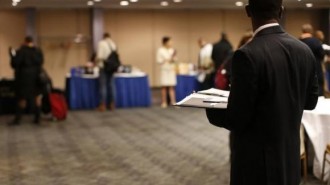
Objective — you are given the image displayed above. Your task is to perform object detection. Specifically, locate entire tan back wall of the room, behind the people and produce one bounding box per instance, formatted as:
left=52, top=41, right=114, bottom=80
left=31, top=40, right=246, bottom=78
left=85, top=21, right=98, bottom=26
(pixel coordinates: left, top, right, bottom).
left=0, top=9, right=322, bottom=88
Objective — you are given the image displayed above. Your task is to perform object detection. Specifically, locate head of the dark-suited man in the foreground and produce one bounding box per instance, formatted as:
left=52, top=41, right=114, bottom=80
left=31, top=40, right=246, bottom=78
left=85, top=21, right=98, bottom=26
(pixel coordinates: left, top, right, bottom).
left=246, top=0, right=283, bottom=22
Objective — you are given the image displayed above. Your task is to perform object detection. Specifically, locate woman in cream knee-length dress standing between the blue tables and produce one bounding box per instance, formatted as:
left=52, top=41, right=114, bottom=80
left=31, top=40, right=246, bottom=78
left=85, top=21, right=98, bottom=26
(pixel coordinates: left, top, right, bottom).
left=157, top=37, right=177, bottom=108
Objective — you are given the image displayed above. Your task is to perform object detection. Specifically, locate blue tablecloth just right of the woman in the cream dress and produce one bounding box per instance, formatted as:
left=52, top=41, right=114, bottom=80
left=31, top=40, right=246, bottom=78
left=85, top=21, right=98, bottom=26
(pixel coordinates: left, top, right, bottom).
left=175, top=75, right=200, bottom=101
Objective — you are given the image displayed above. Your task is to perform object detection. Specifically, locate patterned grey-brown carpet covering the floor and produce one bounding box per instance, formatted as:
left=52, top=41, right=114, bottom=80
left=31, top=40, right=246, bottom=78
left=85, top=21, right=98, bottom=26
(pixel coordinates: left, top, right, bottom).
left=0, top=107, right=320, bottom=185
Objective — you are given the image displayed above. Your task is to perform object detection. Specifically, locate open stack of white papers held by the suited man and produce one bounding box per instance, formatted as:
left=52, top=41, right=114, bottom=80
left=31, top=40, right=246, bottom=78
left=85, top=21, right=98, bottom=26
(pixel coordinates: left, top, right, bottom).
left=176, top=88, right=230, bottom=109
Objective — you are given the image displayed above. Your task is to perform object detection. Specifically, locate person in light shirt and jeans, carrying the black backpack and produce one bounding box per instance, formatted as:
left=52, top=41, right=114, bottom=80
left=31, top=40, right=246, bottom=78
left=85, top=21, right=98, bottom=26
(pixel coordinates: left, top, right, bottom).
left=96, top=33, right=117, bottom=112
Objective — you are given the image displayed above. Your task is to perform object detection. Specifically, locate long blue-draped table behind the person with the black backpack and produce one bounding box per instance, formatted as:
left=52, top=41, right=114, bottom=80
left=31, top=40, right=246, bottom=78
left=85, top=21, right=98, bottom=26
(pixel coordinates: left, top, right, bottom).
left=66, top=73, right=151, bottom=110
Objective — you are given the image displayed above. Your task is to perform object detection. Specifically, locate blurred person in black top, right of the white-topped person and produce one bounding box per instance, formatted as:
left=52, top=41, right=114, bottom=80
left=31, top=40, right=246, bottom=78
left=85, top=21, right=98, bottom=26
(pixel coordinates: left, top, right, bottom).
left=211, top=33, right=233, bottom=71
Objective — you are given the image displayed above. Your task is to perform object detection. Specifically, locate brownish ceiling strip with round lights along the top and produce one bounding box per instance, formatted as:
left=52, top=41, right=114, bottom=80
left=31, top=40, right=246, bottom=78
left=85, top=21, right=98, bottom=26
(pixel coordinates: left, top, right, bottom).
left=0, top=0, right=330, bottom=9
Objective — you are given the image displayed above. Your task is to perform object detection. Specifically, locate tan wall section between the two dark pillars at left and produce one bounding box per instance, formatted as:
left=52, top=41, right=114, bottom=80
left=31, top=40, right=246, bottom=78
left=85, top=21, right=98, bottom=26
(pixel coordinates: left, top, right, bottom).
left=37, top=9, right=92, bottom=88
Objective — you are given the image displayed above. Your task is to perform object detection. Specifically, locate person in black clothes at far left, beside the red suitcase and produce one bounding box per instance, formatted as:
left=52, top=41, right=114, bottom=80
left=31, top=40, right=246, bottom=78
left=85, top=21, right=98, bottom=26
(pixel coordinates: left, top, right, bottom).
left=10, top=36, right=44, bottom=125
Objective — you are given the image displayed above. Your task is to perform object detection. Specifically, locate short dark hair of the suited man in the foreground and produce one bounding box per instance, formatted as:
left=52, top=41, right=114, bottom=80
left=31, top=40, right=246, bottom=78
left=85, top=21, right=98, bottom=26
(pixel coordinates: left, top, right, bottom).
left=249, top=0, right=283, bottom=19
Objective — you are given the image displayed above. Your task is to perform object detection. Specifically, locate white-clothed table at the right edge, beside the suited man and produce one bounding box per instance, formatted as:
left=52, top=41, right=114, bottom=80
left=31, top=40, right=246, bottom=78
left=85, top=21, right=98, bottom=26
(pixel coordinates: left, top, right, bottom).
left=302, top=97, right=330, bottom=179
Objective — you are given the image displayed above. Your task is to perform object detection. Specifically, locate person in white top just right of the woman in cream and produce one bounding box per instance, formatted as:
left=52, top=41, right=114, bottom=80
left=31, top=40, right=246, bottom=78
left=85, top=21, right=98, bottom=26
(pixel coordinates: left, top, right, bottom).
left=198, top=38, right=214, bottom=90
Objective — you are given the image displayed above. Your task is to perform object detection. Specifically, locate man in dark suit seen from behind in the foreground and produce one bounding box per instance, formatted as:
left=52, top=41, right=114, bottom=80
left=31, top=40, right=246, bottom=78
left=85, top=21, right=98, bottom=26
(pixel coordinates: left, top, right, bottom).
left=206, top=0, right=318, bottom=185
